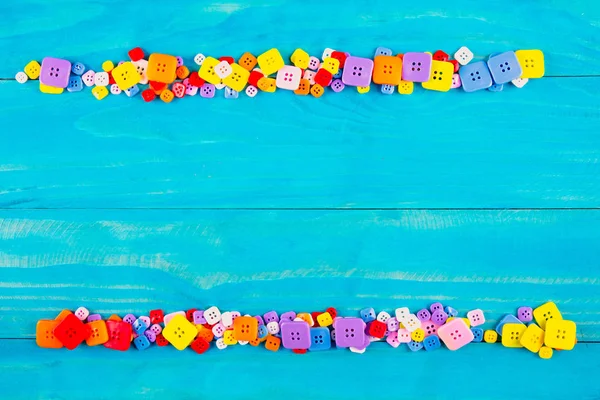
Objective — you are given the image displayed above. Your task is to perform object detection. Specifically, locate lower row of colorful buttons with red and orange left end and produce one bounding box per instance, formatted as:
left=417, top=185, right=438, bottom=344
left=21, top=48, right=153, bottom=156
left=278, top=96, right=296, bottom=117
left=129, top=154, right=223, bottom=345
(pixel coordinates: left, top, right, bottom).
left=37, top=302, right=575, bottom=357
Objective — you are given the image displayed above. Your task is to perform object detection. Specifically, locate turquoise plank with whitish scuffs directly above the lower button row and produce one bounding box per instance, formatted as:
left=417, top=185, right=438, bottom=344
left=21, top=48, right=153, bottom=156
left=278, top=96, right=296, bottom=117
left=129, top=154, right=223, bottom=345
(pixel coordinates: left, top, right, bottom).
left=0, top=210, right=600, bottom=341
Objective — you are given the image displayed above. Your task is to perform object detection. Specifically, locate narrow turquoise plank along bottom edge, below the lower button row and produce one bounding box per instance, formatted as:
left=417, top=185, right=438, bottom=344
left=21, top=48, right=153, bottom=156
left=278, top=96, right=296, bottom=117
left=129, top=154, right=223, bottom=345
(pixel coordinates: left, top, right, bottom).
left=0, top=340, right=600, bottom=400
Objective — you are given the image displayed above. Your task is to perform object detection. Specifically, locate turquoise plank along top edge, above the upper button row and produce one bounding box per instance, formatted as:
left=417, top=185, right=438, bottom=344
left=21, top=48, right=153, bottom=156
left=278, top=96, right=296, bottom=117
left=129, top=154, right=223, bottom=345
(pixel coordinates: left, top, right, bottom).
left=0, top=0, right=600, bottom=77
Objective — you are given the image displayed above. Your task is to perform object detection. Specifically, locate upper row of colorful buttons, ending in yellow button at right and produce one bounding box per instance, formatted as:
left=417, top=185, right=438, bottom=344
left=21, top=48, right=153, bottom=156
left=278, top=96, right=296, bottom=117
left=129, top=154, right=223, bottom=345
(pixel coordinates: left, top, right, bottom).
left=17, top=48, right=543, bottom=100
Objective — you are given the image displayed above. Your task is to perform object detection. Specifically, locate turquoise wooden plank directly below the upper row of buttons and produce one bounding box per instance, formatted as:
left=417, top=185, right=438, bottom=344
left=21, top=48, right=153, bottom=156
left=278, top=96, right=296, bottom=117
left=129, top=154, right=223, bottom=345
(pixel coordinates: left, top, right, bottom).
left=0, top=78, right=600, bottom=208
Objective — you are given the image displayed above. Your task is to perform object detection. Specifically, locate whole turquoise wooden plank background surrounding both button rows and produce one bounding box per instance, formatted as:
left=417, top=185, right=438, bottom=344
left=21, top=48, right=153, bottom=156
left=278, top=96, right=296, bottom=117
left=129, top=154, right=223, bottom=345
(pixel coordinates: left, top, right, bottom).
left=0, top=0, right=600, bottom=399
